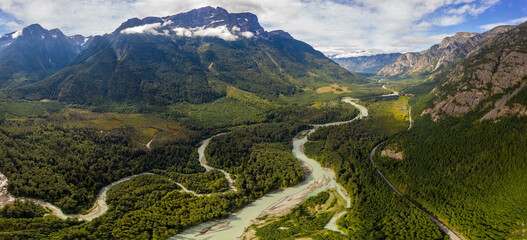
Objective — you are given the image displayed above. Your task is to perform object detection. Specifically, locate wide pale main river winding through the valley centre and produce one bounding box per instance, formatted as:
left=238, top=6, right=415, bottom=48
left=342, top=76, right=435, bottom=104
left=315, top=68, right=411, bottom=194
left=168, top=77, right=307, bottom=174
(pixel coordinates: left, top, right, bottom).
left=170, top=98, right=368, bottom=240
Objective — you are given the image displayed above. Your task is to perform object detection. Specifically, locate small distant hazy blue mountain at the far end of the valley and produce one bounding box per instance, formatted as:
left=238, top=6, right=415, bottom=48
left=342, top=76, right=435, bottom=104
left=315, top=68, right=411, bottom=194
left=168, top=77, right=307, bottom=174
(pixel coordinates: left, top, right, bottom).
left=332, top=53, right=401, bottom=74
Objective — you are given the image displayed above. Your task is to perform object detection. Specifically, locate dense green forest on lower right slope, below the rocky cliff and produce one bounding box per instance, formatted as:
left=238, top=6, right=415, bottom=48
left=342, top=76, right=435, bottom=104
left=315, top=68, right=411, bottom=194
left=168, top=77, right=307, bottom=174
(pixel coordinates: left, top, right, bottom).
left=378, top=114, right=527, bottom=239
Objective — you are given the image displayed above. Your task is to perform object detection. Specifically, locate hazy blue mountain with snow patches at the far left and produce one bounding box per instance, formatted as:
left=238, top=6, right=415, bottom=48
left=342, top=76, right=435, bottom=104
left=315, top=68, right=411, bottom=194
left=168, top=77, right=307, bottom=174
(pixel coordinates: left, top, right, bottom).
left=0, top=24, right=89, bottom=87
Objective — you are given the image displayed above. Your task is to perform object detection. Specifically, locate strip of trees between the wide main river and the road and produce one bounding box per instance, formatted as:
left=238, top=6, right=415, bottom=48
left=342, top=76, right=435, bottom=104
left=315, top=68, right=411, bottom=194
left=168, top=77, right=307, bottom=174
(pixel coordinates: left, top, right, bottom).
left=305, top=117, right=444, bottom=239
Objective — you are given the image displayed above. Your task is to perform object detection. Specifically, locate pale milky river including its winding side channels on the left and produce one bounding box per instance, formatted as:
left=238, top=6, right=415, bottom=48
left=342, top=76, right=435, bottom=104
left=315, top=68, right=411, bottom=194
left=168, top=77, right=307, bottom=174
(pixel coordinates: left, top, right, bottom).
left=0, top=98, right=368, bottom=236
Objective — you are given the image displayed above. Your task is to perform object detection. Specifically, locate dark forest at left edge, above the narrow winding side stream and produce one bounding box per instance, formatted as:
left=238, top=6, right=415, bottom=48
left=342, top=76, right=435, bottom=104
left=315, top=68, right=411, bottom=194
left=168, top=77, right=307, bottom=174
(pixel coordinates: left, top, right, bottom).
left=0, top=119, right=204, bottom=213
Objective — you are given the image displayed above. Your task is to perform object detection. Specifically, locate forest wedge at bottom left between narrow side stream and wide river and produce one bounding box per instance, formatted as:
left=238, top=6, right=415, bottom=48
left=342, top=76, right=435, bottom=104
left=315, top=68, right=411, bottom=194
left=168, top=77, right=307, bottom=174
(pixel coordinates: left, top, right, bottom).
left=46, top=175, right=241, bottom=239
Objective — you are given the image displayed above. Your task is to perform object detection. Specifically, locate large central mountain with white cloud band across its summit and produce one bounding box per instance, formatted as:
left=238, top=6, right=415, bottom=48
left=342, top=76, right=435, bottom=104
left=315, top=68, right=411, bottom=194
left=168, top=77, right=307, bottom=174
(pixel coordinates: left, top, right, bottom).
left=17, top=7, right=364, bottom=104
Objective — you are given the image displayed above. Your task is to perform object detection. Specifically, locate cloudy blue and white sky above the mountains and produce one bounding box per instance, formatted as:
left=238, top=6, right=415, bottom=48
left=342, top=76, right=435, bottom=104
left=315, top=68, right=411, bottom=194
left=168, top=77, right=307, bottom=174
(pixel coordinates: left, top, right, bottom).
left=0, top=0, right=527, bottom=57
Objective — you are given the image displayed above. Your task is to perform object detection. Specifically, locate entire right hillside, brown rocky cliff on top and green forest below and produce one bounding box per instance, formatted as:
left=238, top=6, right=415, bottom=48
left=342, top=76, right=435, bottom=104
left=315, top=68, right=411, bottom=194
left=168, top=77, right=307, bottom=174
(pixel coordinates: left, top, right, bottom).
left=376, top=20, right=527, bottom=239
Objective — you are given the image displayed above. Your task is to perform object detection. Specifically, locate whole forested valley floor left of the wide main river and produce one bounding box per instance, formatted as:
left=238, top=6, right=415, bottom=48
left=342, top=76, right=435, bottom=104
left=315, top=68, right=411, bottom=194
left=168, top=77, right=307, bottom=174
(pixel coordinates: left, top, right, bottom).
left=0, top=95, right=364, bottom=239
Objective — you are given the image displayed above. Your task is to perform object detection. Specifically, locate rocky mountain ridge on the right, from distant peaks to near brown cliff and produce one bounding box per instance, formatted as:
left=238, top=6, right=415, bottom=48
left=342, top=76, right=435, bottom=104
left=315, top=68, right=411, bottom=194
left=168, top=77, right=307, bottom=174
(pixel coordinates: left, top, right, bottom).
left=334, top=23, right=527, bottom=121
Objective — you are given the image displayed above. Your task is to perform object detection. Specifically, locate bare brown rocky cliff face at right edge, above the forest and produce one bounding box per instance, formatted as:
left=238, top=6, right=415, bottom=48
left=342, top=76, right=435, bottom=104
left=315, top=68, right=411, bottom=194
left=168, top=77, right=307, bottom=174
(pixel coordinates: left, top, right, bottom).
left=423, top=23, right=527, bottom=120
